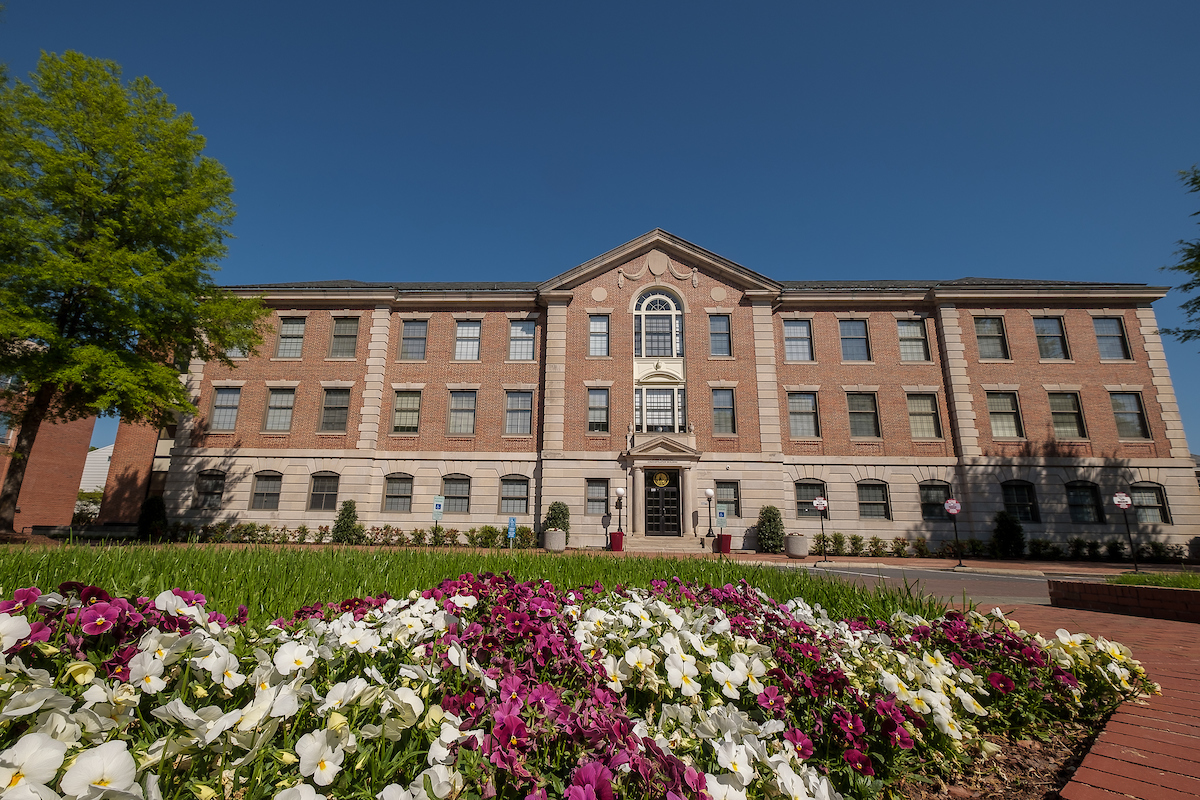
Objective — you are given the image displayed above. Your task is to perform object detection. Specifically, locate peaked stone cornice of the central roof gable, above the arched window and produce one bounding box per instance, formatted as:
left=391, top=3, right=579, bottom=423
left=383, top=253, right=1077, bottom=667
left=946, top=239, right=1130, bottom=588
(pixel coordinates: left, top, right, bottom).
left=538, top=228, right=784, bottom=291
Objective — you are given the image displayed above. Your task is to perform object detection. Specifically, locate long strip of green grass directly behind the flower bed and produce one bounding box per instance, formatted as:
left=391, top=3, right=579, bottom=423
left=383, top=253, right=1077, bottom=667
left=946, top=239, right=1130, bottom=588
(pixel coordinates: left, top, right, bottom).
left=0, top=545, right=946, bottom=622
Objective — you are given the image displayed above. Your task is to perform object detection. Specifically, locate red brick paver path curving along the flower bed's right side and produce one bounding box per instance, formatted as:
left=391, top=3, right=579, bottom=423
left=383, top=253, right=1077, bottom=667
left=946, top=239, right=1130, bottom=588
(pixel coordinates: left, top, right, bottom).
left=1003, top=606, right=1200, bottom=800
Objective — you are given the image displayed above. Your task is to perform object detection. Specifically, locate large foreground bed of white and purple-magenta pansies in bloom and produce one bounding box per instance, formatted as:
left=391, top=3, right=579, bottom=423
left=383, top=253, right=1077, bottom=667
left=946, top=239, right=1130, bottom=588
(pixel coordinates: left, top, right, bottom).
left=0, top=575, right=1157, bottom=800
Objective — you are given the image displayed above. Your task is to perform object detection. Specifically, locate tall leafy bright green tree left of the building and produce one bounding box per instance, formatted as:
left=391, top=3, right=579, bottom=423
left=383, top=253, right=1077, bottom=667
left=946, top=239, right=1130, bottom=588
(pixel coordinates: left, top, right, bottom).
left=0, top=52, right=264, bottom=531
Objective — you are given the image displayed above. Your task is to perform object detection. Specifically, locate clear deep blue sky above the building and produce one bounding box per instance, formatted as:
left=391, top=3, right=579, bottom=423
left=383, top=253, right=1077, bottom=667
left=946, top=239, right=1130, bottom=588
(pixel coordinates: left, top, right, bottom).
left=0, top=0, right=1200, bottom=452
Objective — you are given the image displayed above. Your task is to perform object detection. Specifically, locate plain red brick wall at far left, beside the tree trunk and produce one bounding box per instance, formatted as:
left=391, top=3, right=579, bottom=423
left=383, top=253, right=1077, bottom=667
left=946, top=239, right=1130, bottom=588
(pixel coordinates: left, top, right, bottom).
left=0, top=416, right=96, bottom=531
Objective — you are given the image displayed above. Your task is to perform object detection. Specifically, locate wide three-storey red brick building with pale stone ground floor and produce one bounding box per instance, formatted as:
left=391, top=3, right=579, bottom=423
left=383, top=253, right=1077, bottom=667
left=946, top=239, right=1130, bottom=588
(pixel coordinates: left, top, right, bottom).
left=104, top=230, right=1200, bottom=547
